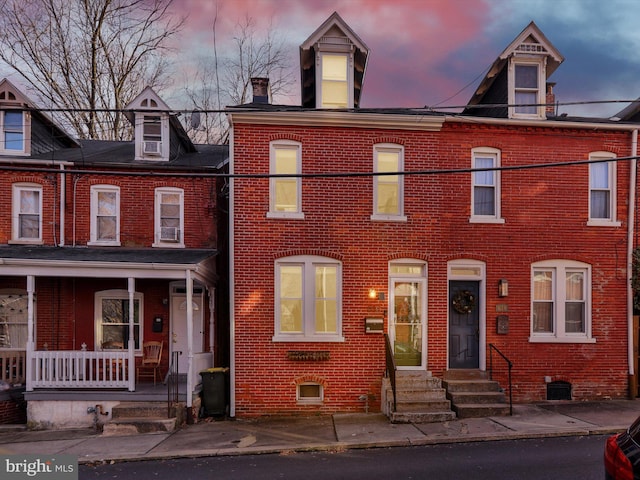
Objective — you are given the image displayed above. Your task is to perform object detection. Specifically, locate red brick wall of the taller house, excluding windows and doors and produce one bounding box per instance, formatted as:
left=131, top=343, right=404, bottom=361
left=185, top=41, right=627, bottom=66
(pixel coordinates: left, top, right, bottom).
left=233, top=118, right=631, bottom=416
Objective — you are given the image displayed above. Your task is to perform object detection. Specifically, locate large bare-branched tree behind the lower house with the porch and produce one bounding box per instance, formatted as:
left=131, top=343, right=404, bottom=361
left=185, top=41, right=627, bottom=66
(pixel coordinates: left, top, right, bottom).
left=0, top=0, right=184, bottom=140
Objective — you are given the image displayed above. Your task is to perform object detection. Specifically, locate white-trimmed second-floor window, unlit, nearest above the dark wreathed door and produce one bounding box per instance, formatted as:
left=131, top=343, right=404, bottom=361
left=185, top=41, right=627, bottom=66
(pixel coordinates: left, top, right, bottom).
left=470, top=147, right=504, bottom=223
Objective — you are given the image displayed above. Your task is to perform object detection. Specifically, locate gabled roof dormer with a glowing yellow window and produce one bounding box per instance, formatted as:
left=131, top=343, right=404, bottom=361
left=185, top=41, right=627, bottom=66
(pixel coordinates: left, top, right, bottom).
left=300, top=12, right=369, bottom=108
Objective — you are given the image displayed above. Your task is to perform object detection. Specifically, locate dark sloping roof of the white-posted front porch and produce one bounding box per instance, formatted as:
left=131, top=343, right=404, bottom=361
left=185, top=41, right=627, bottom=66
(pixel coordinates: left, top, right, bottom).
left=0, top=245, right=218, bottom=265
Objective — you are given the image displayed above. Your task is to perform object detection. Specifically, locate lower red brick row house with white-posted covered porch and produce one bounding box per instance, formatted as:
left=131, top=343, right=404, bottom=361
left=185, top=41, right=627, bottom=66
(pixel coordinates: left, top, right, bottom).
left=0, top=80, right=228, bottom=427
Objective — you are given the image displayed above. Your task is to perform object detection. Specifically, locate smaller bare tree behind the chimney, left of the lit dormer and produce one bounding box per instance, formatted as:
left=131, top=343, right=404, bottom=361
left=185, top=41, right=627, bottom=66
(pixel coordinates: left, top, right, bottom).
left=185, top=10, right=294, bottom=143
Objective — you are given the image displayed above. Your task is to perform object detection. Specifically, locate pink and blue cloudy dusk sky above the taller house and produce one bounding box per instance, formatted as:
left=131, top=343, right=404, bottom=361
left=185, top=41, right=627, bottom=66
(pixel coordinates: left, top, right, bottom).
left=170, top=0, right=640, bottom=117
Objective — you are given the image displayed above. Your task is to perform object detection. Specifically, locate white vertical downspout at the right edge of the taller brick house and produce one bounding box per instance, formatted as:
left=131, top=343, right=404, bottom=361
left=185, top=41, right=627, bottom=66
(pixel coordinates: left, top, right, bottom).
left=627, top=130, right=638, bottom=398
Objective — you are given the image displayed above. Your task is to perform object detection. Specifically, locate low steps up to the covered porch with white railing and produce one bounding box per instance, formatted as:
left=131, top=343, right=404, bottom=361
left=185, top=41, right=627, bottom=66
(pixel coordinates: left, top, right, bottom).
left=102, top=402, right=176, bottom=436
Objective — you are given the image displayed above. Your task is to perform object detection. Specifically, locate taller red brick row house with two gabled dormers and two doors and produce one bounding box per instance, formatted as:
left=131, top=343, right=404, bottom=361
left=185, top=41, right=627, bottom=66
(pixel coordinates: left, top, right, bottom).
left=228, top=13, right=638, bottom=421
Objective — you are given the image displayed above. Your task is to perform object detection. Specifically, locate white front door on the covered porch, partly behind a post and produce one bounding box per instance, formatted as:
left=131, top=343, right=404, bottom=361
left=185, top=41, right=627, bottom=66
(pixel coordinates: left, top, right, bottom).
left=170, top=288, right=204, bottom=375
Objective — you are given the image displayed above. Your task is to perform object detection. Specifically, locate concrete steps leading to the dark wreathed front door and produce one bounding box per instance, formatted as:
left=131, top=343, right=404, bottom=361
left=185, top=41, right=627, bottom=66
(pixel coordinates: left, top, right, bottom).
left=442, top=370, right=510, bottom=418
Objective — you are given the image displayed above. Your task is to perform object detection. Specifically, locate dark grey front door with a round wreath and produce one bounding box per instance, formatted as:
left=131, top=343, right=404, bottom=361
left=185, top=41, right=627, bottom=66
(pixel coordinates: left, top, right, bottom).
left=449, top=280, right=480, bottom=368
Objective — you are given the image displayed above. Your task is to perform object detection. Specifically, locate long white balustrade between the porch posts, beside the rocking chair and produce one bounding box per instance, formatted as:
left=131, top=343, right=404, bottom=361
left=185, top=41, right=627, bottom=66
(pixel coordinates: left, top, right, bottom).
left=27, top=350, right=135, bottom=390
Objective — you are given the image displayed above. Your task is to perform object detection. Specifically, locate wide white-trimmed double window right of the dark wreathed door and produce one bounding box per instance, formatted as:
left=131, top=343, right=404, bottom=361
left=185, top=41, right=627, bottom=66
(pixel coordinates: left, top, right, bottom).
left=530, top=260, right=595, bottom=343
